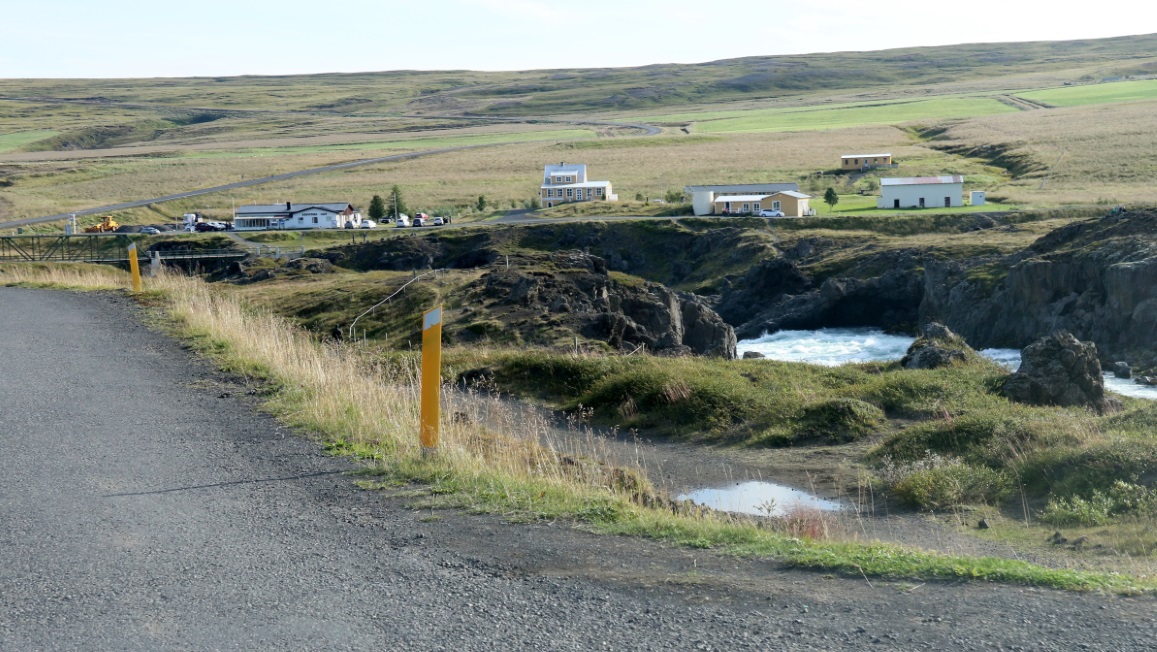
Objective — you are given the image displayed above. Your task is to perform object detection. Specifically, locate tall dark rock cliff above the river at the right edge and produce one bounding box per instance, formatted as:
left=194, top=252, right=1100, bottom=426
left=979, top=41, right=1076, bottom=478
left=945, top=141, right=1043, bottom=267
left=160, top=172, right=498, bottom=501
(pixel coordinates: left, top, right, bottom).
left=920, top=212, right=1157, bottom=369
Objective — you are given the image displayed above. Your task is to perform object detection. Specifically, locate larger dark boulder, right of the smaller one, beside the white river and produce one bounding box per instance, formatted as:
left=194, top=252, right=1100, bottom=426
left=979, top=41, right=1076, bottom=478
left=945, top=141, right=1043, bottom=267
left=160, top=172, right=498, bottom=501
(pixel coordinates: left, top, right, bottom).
left=1004, top=331, right=1120, bottom=413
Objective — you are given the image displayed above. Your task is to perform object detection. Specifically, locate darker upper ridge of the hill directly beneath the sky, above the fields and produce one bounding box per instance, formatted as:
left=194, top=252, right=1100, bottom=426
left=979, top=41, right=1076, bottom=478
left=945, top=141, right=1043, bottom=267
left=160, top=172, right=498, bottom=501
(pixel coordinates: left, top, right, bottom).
left=0, top=35, right=1157, bottom=116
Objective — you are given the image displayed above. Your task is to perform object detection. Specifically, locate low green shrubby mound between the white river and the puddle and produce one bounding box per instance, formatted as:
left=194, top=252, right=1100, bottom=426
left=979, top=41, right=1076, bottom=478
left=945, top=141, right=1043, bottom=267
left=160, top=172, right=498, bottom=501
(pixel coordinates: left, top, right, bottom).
left=448, top=350, right=1157, bottom=524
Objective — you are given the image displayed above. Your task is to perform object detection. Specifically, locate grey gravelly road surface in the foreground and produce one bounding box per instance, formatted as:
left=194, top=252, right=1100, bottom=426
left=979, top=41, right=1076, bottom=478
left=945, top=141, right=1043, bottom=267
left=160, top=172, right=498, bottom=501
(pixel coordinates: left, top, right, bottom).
left=0, top=288, right=1157, bottom=651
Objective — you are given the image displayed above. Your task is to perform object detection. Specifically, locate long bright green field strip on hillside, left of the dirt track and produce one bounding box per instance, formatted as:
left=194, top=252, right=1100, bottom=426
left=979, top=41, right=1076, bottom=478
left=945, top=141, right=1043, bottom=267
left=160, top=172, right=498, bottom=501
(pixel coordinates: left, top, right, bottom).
left=648, top=97, right=1016, bottom=133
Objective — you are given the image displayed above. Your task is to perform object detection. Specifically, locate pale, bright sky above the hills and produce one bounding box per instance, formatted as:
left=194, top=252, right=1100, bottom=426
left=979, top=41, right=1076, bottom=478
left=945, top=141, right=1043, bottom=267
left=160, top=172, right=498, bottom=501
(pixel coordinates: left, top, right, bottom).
left=0, top=0, right=1157, bottom=79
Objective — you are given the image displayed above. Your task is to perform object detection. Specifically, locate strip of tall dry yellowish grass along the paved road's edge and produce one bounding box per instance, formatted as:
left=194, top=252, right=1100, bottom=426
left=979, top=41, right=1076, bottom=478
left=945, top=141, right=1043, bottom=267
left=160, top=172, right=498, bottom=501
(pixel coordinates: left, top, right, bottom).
left=6, top=263, right=1157, bottom=593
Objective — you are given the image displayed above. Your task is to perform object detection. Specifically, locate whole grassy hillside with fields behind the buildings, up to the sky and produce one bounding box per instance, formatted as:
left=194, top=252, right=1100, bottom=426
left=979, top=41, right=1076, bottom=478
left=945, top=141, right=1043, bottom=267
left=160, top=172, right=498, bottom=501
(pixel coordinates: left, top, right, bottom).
left=0, top=37, right=1157, bottom=224
